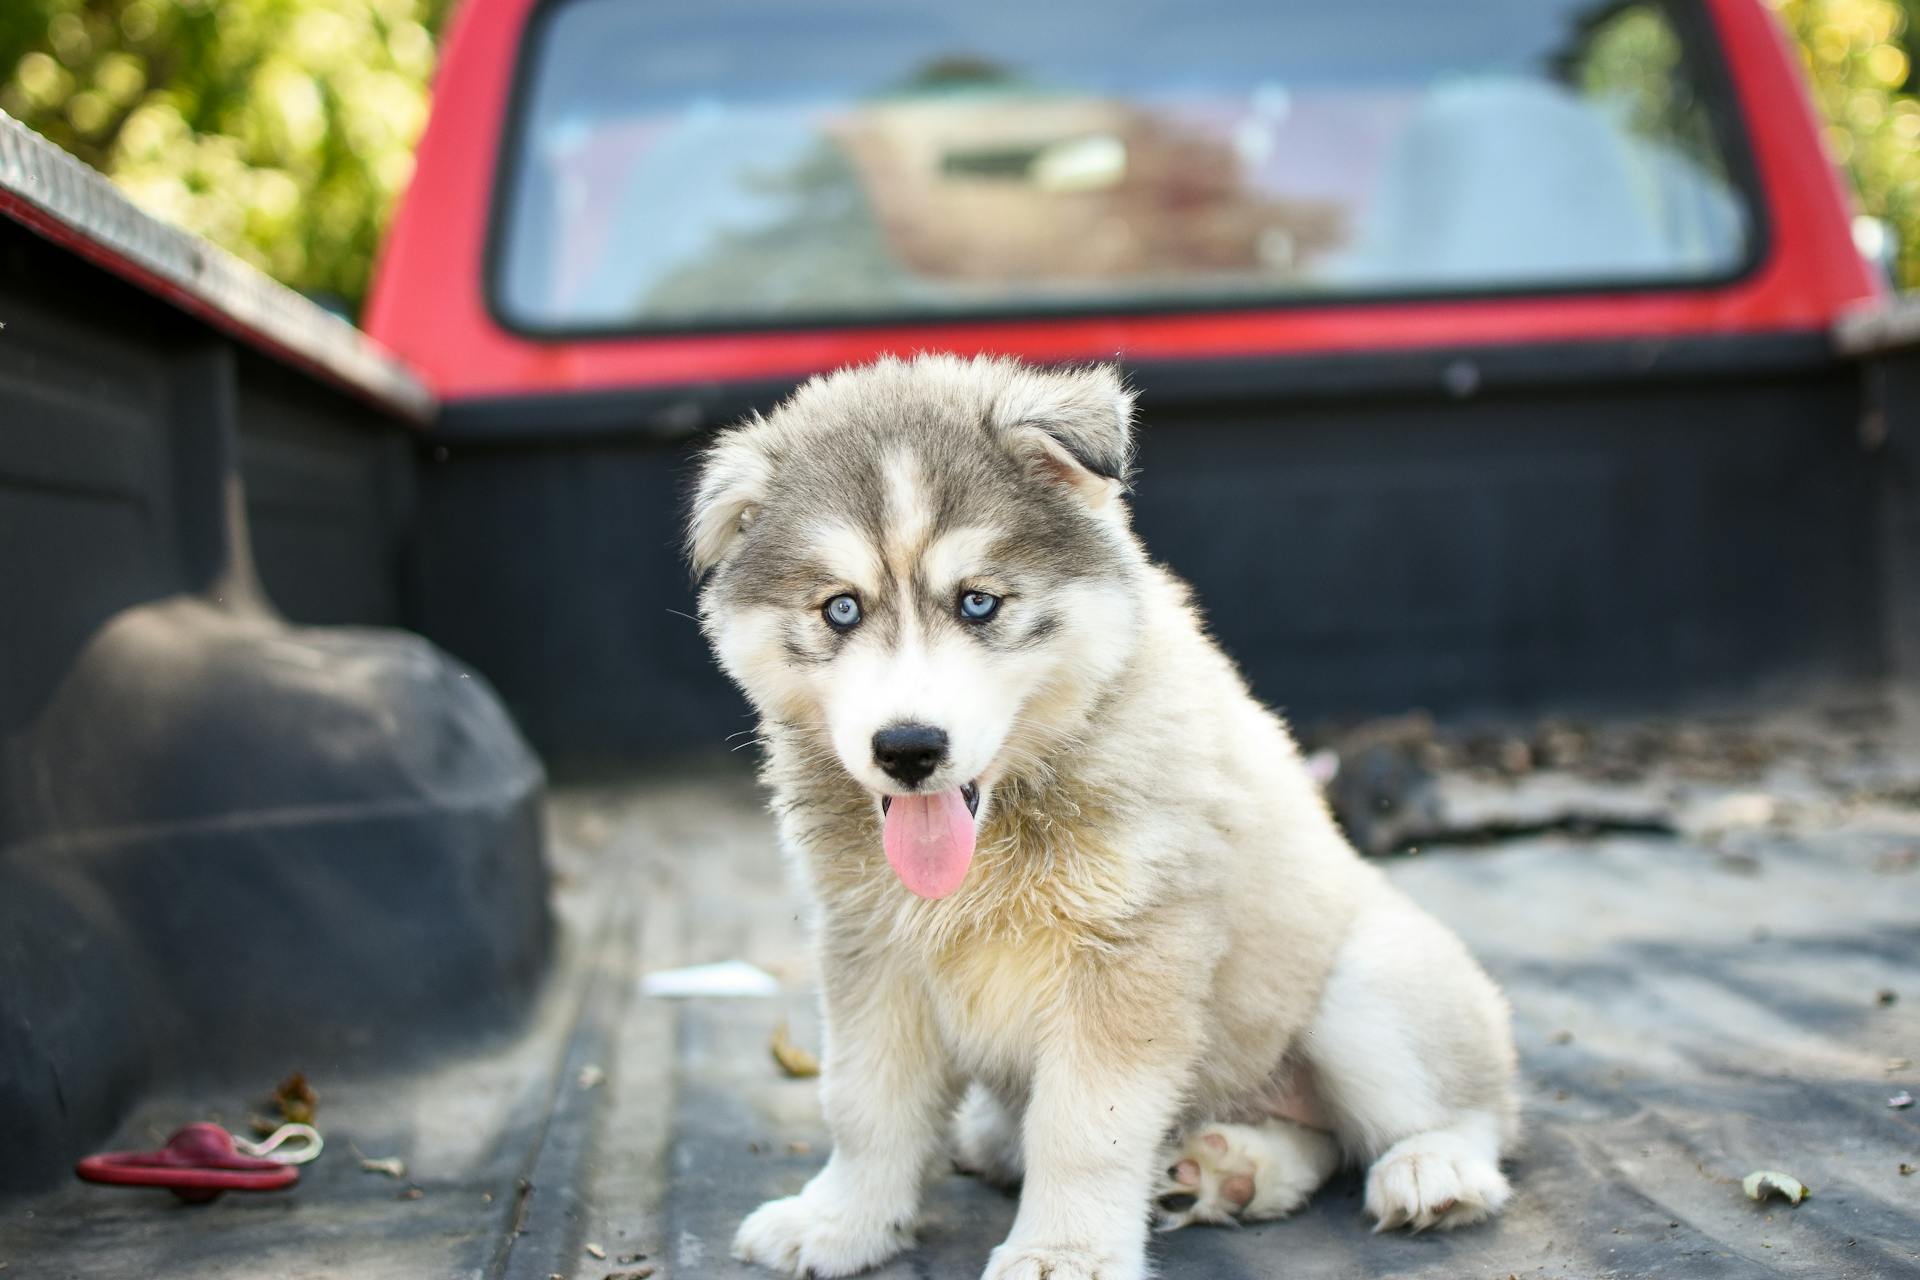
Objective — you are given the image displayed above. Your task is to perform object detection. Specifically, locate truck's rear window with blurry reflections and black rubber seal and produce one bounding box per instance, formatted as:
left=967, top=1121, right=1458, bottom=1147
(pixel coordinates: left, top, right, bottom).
left=492, top=0, right=1755, bottom=332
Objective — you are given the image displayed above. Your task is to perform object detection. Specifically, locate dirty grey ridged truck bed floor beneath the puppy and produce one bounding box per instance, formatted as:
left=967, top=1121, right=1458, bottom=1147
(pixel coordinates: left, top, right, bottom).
left=0, top=710, right=1920, bottom=1280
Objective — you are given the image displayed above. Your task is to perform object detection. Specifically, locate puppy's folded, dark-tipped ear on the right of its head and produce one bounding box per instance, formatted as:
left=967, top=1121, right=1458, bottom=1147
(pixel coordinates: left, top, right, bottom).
left=995, top=365, right=1133, bottom=507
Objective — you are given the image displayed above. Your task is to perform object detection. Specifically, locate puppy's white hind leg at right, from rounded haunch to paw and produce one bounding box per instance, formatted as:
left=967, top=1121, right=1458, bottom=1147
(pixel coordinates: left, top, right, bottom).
left=1304, top=892, right=1517, bottom=1230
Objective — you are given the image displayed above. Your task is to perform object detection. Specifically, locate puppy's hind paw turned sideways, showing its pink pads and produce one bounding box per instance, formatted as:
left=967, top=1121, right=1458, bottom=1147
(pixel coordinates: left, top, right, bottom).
left=1156, top=1121, right=1338, bottom=1230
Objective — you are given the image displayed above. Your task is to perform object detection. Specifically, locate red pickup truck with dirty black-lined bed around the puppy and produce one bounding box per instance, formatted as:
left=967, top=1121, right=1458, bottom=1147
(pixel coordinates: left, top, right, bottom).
left=0, top=0, right=1920, bottom=1280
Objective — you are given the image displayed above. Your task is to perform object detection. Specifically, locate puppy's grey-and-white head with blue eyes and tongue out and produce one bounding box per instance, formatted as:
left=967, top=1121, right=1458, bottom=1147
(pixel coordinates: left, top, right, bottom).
left=687, top=357, right=1144, bottom=896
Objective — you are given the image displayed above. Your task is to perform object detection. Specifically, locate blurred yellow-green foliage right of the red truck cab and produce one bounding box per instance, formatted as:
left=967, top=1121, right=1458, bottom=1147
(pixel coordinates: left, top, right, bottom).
left=1770, top=0, right=1920, bottom=288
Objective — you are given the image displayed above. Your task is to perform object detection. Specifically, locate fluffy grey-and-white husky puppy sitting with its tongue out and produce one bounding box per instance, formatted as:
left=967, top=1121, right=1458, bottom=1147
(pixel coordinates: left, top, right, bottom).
left=687, top=357, right=1515, bottom=1280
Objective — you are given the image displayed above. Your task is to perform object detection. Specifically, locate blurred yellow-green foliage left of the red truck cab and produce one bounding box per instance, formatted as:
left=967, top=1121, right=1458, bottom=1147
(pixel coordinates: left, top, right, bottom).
left=0, top=0, right=449, bottom=307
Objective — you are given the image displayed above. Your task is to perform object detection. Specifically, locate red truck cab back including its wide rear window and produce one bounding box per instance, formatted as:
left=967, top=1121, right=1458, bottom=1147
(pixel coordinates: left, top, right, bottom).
left=367, top=0, right=1878, bottom=403
